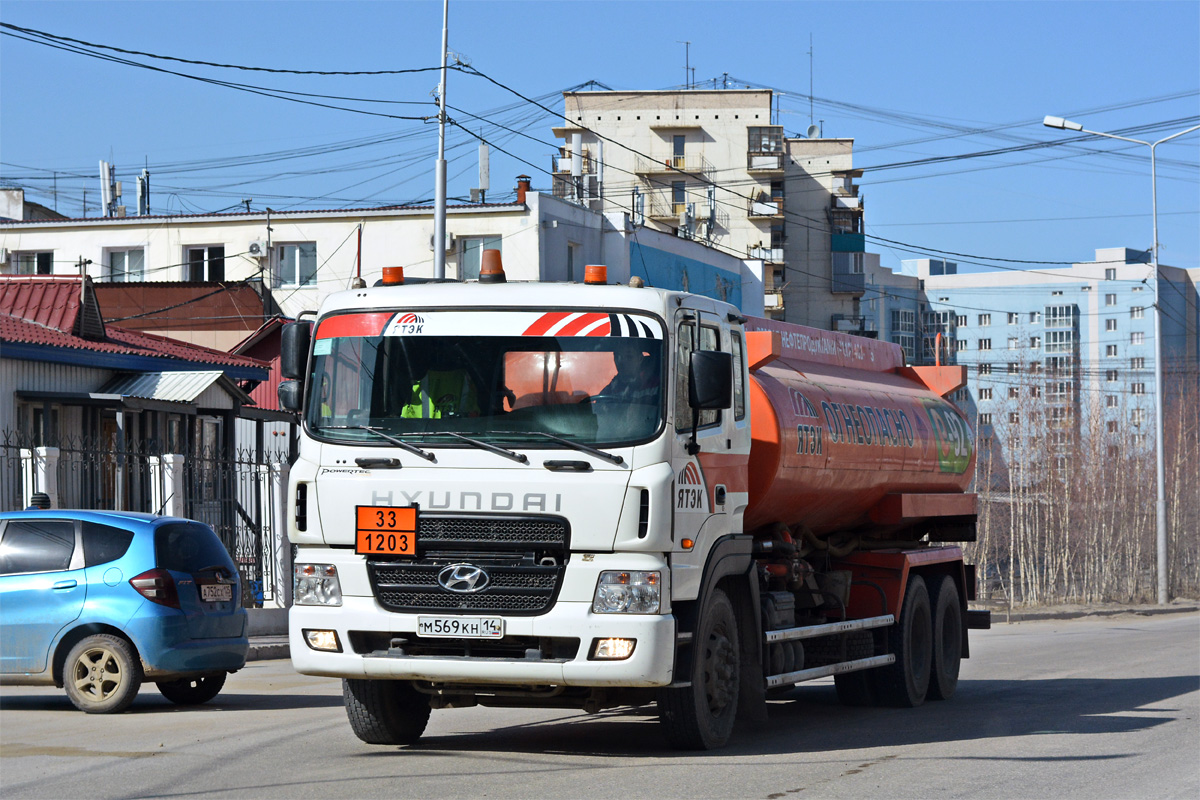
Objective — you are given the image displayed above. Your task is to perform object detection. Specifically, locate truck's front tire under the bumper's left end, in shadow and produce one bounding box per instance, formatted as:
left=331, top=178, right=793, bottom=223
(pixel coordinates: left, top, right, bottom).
left=342, top=678, right=430, bottom=745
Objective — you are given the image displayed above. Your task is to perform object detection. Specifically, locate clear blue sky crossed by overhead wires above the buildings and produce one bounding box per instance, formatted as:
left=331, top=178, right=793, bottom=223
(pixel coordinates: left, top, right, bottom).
left=0, top=0, right=1200, bottom=269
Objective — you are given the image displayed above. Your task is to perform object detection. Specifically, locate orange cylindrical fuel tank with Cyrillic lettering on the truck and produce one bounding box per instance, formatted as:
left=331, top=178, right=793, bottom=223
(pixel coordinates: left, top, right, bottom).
left=744, top=319, right=976, bottom=535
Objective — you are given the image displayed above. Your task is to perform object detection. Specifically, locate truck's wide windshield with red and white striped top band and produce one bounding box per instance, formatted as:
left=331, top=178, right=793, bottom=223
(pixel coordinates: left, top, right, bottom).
left=306, top=311, right=665, bottom=447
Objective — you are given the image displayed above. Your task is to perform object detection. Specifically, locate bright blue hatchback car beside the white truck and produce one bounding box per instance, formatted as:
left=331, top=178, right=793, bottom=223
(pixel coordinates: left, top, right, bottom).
left=0, top=510, right=250, bottom=714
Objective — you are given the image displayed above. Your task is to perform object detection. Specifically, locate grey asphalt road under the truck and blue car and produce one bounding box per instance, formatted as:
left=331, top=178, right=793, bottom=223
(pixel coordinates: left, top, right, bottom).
left=0, top=613, right=1200, bottom=800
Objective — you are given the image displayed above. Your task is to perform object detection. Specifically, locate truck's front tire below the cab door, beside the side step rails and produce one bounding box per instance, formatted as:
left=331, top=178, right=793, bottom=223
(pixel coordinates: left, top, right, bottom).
left=659, top=589, right=742, bottom=750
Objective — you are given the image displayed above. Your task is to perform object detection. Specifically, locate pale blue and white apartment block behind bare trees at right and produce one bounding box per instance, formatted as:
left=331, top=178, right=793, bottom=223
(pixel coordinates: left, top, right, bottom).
left=902, top=247, right=1200, bottom=460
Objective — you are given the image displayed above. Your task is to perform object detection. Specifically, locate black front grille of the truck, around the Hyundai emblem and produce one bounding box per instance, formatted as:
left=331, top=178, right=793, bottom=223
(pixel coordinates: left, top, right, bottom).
left=367, top=515, right=569, bottom=615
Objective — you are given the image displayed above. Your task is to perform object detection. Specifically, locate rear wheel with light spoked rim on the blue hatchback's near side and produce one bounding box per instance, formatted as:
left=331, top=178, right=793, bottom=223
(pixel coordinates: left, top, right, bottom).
left=62, top=633, right=142, bottom=714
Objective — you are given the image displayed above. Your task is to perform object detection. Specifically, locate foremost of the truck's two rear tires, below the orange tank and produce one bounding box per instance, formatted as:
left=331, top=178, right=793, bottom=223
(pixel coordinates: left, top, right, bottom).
left=872, top=575, right=934, bottom=708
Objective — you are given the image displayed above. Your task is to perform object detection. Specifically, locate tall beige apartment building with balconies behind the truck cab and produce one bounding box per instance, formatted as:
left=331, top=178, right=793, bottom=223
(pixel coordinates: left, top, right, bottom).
left=552, top=90, right=877, bottom=335
